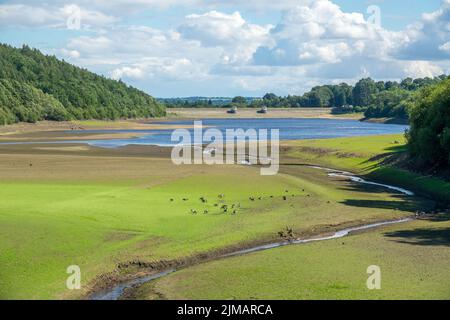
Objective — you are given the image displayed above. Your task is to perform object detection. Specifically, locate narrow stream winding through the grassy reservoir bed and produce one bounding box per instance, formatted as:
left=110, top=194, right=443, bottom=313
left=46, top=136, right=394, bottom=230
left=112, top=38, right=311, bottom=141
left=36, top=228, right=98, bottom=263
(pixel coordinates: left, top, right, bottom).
left=89, top=166, right=414, bottom=300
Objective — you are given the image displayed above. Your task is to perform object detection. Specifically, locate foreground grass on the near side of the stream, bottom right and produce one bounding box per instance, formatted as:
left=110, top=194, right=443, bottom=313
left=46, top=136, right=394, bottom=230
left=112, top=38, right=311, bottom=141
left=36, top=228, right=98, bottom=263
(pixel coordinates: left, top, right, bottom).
left=145, top=215, right=450, bottom=299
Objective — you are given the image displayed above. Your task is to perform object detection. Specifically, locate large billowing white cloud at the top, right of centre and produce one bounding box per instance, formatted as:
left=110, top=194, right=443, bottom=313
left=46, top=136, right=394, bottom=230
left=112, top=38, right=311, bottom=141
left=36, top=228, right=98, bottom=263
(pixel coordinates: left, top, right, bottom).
left=254, top=0, right=403, bottom=66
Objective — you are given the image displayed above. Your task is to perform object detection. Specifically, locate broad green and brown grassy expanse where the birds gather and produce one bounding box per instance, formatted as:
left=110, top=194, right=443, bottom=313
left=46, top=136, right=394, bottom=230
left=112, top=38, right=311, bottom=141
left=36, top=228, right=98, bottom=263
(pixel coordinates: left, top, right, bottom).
left=0, top=140, right=426, bottom=299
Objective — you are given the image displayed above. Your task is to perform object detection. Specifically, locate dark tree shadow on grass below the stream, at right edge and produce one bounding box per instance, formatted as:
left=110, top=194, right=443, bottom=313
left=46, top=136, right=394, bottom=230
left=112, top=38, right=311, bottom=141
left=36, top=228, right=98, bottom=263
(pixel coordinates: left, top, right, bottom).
left=384, top=228, right=450, bottom=246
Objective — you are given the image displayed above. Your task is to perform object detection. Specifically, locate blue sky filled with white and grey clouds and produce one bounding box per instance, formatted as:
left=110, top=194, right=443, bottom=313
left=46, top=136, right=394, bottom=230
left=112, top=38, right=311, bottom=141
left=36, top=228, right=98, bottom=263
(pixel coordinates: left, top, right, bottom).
left=0, top=0, right=450, bottom=97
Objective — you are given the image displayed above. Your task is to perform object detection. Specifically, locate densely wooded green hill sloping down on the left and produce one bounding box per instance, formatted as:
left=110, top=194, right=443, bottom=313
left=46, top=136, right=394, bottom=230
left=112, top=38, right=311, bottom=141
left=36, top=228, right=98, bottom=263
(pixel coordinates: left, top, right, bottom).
left=0, top=44, right=165, bottom=125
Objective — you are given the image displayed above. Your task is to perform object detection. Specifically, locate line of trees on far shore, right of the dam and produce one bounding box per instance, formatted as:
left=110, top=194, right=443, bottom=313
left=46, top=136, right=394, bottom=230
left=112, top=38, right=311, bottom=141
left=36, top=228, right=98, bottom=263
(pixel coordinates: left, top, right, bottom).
left=228, top=75, right=448, bottom=118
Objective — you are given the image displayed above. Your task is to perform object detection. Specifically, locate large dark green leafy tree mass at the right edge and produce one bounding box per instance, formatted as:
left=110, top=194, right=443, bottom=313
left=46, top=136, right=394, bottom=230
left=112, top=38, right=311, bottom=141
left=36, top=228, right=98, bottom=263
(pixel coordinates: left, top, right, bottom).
left=407, top=79, right=450, bottom=167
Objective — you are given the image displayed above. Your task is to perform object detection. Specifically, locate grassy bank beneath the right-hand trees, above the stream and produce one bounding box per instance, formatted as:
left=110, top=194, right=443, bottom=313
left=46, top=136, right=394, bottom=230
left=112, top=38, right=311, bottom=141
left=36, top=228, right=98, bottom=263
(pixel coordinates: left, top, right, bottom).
left=288, top=135, right=450, bottom=203
